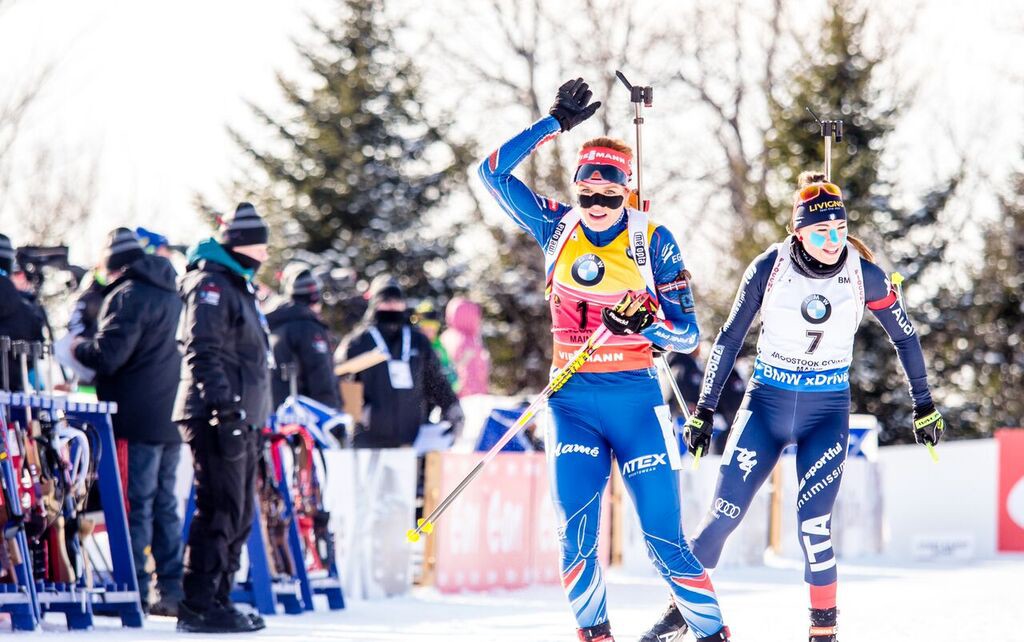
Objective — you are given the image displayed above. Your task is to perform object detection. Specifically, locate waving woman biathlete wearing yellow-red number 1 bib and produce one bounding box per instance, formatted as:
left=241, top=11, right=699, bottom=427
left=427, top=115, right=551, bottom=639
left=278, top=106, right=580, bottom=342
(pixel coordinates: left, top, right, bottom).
left=480, top=79, right=729, bottom=642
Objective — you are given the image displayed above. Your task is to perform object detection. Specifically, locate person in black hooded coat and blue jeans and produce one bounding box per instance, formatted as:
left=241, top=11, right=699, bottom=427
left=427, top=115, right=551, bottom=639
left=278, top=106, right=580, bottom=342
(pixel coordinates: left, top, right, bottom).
left=73, top=227, right=182, bottom=615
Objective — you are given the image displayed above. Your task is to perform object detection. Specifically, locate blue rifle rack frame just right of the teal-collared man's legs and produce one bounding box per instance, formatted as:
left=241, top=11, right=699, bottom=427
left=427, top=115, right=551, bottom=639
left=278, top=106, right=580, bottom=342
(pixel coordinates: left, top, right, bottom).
left=182, top=421, right=345, bottom=615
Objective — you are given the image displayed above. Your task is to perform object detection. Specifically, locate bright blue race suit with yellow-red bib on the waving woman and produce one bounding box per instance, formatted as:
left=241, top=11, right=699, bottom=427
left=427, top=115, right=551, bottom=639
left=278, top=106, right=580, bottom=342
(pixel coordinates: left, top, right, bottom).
left=479, top=117, right=722, bottom=637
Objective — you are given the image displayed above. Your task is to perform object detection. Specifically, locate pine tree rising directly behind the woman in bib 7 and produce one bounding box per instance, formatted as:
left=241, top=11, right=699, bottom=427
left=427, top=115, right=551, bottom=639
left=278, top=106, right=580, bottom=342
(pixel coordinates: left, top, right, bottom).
left=737, top=0, right=958, bottom=441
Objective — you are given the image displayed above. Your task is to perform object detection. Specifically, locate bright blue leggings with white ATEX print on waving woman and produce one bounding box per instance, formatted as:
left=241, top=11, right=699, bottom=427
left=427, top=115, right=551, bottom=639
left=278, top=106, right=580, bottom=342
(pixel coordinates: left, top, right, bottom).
left=547, top=370, right=722, bottom=637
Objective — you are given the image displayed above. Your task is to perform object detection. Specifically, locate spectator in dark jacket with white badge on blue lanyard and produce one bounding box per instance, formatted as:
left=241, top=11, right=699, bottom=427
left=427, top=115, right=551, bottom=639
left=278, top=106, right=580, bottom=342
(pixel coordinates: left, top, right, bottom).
left=338, top=275, right=463, bottom=448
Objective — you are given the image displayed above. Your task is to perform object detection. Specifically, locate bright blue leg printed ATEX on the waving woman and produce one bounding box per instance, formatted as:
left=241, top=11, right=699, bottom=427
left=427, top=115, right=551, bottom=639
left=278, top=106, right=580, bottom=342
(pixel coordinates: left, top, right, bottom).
left=601, top=380, right=723, bottom=639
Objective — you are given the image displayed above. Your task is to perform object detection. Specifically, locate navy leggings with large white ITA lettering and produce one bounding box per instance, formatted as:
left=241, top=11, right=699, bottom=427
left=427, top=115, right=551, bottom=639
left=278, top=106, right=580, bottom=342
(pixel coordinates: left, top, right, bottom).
left=693, top=382, right=850, bottom=599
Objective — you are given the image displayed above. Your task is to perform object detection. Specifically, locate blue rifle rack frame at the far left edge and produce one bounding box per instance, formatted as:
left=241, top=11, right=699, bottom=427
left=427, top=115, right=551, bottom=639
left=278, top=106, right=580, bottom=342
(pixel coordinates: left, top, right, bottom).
left=0, top=390, right=142, bottom=631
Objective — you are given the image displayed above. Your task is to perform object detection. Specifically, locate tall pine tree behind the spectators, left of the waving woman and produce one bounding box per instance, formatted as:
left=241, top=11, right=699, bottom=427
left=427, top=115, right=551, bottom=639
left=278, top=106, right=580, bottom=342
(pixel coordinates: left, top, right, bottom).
left=231, top=0, right=468, bottom=331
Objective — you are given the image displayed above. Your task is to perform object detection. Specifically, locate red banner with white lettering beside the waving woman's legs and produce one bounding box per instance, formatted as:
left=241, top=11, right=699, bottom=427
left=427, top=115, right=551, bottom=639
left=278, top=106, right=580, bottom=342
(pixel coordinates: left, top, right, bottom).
left=431, top=453, right=610, bottom=593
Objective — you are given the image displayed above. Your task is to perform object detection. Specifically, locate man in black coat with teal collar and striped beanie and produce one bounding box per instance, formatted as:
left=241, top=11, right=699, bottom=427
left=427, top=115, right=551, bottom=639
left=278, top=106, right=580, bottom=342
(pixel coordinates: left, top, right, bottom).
left=173, top=203, right=270, bottom=633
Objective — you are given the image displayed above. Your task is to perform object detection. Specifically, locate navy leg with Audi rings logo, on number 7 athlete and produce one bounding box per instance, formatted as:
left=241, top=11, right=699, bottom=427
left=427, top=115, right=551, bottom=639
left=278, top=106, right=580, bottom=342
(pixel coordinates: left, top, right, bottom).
left=692, top=386, right=796, bottom=568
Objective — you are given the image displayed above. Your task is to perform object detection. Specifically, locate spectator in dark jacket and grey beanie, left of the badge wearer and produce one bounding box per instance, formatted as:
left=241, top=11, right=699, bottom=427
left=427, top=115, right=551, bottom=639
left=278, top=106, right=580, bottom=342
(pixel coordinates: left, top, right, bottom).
left=266, top=264, right=341, bottom=409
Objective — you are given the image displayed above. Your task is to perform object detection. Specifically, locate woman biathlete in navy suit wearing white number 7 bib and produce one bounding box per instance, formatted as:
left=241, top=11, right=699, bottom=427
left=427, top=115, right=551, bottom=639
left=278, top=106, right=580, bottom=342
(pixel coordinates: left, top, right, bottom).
left=643, top=172, right=945, bottom=642
